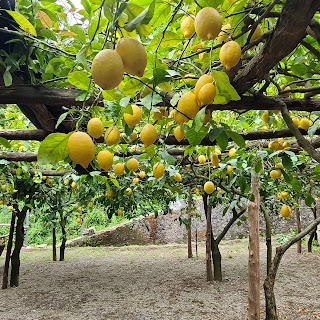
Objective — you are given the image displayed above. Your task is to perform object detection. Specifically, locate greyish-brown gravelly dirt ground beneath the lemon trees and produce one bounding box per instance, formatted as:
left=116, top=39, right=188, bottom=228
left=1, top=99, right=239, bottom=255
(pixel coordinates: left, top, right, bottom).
left=0, top=240, right=320, bottom=320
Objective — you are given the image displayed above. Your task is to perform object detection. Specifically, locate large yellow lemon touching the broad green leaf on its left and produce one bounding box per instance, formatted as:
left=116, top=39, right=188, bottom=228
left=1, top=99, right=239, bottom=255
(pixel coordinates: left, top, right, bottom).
left=67, top=131, right=94, bottom=168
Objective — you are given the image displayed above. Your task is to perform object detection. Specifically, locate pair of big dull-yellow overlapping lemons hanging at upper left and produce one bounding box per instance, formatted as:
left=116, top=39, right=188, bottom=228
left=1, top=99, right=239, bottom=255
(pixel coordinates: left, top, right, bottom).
left=91, top=37, right=147, bottom=90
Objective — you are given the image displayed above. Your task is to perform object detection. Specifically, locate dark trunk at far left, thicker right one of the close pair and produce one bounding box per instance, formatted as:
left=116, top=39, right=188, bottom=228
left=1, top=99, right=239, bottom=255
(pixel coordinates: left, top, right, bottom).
left=10, top=207, right=28, bottom=287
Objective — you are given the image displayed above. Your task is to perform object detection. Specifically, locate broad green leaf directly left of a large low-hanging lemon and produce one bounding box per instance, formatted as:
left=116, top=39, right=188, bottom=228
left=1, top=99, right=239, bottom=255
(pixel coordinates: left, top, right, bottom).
left=38, top=132, right=72, bottom=164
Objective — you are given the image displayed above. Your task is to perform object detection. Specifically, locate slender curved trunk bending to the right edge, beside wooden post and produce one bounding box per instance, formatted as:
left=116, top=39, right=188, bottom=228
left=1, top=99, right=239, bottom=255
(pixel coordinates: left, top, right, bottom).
left=263, top=218, right=320, bottom=320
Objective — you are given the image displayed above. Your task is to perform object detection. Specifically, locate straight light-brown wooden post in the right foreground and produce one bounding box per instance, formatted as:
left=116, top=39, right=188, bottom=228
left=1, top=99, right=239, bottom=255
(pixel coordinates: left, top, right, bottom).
left=247, top=176, right=260, bottom=320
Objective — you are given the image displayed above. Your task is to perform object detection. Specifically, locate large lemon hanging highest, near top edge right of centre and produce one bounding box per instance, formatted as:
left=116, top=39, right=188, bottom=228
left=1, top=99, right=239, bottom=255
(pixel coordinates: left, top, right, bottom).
left=194, top=7, right=222, bottom=40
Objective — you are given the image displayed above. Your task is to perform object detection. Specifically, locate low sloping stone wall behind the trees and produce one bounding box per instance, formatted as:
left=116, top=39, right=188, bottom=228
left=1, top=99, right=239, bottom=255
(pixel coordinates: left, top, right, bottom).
left=68, top=201, right=313, bottom=246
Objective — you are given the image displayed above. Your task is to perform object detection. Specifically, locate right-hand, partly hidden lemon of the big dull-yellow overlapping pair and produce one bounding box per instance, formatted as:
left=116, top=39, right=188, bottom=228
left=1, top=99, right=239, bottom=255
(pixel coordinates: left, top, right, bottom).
left=115, top=37, right=147, bottom=77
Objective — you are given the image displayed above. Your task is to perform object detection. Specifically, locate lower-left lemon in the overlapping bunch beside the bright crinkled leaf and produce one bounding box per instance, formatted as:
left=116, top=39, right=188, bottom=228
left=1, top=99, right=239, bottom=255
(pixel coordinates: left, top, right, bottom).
left=174, top=91, right=199, bottom=124
